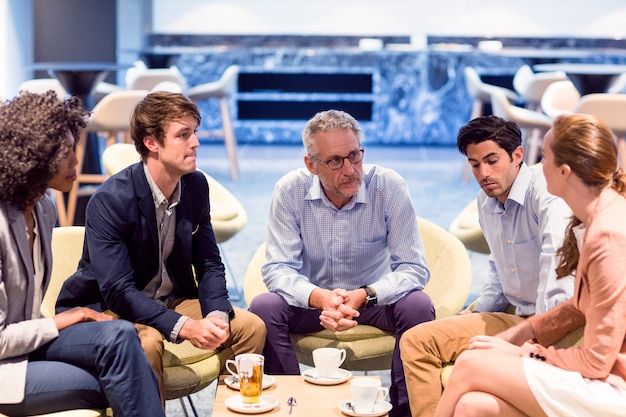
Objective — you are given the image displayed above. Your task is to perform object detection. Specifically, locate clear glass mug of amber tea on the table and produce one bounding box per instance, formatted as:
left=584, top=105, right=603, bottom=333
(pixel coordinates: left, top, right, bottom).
left=226, top=353, right=265, bottom=404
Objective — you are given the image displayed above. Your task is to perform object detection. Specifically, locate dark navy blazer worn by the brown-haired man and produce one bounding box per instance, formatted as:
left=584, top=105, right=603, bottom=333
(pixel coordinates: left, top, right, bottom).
left=56, top=163, right=233, bottom=338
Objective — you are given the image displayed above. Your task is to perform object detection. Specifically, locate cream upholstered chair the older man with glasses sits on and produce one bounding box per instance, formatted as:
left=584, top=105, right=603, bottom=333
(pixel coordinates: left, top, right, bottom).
left=244, top=218, right=472, bottom=371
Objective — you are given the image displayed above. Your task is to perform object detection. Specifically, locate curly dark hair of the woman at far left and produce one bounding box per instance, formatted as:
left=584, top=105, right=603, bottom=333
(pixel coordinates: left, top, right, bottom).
left=0, top=90, right=89, bottom=210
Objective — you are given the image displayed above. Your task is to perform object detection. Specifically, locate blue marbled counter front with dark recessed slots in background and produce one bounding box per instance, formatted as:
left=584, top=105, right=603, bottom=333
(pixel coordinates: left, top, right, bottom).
left=153, top=35, right=626, bottom=146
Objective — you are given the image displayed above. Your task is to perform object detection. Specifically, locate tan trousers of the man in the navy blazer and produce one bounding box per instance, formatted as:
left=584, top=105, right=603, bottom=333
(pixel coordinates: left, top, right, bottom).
left=107, top=299, right=265, bottom=407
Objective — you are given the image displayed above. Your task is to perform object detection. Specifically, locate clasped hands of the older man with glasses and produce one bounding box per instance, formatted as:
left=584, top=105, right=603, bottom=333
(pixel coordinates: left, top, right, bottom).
left=316, top=288, right=365, bottom=332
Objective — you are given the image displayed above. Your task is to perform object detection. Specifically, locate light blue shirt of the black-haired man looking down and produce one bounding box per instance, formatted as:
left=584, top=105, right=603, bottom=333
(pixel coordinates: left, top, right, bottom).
left=474, top=164, right=574, bottom=316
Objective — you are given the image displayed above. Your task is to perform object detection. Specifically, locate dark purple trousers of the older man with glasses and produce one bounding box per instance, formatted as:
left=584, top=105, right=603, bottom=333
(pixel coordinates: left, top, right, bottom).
left=249, top=291, right=435, bottom=416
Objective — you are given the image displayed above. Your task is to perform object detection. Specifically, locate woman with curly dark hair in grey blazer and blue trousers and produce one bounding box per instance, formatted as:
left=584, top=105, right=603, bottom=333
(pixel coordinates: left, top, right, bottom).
left=0, top=91, right=165, bottom=417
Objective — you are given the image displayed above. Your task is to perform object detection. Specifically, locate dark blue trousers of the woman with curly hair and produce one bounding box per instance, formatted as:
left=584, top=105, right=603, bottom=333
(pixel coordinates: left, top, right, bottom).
left=0, top=320, right=165, bottom=417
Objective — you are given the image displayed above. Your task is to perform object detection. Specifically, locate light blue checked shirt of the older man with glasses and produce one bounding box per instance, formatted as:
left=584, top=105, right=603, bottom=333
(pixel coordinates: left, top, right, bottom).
left=263, top=164, right=430, bottom=308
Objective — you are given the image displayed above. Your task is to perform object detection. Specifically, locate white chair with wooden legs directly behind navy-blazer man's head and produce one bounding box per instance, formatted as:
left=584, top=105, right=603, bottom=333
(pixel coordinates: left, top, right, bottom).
left=65, top=90, right=147, bottom=226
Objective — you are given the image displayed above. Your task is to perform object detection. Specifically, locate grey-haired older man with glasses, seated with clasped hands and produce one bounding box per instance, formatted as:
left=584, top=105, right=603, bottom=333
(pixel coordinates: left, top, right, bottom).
left=250, top=110, right=435, bottom=416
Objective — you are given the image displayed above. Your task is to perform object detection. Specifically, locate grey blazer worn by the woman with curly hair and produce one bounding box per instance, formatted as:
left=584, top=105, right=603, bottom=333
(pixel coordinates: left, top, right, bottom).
left=0, top=196, right=59, bottom=404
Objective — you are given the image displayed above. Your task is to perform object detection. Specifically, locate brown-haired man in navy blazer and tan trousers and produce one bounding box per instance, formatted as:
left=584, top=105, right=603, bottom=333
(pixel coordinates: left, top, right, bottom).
left=57, top=92, right=265, bottom=398
